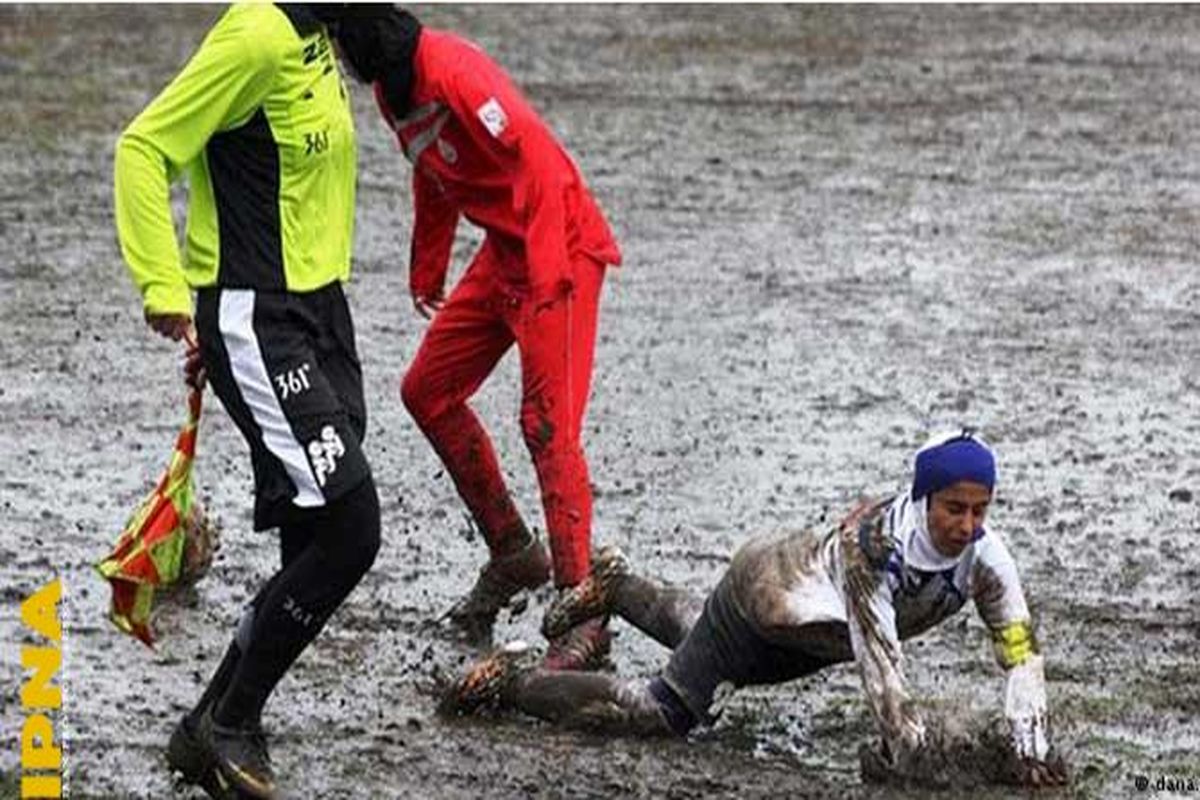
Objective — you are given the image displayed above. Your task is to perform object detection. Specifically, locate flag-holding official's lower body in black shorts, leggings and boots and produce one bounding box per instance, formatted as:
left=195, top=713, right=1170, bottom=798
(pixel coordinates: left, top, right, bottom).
left=192, top=284, right=379, bottom=795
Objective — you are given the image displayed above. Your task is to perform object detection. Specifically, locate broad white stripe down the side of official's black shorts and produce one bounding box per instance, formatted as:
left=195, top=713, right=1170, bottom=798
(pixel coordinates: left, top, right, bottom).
left=217, top=289, right=325, bottom=509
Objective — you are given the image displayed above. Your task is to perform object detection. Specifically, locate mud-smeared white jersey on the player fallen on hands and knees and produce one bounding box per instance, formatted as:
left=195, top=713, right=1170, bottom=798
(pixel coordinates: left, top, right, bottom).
left=731, top=494, right=1037, bottom=758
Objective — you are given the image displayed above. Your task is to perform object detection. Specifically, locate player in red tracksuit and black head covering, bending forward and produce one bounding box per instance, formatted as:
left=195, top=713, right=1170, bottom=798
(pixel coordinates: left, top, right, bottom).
left=335, top=6, right=620, bottom=668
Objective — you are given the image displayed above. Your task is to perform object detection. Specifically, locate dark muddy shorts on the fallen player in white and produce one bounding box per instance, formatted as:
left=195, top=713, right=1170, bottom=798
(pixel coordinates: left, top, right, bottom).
left=662, top=572, right=835, bottom=724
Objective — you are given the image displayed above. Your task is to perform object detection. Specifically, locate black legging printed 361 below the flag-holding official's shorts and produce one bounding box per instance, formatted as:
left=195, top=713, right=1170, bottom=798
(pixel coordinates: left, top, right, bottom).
left=214, top=479, right=379, bottom=727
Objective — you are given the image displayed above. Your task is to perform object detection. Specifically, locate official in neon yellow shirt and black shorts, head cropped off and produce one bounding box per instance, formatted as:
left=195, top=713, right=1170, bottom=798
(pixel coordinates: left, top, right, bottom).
left=115, top=4, right=379, bottom=798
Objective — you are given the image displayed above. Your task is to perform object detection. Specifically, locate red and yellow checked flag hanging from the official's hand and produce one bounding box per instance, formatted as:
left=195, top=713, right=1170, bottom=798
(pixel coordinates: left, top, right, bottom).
left=96, top=390, right=217, bottom=646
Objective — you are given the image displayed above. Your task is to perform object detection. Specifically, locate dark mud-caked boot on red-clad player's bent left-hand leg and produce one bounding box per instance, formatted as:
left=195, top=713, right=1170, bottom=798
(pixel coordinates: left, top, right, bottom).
left=446, top=537, right=550, bottom=644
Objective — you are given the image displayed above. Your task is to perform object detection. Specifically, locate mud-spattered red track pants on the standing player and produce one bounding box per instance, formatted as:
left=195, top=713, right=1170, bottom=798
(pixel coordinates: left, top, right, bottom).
left=401, top=241, right=605, bottom=587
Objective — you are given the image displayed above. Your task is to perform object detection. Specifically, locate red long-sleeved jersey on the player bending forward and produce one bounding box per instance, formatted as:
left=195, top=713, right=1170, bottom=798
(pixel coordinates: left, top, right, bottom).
left=376, top=28, right=620, bottom=295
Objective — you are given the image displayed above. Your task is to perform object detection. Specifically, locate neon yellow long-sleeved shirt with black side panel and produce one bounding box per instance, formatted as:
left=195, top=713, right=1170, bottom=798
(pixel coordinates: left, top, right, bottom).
left=114, top=4, right=356, bottom=314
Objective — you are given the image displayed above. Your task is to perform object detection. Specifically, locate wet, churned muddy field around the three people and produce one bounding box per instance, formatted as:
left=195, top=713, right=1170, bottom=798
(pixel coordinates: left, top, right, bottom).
left=0, top=6, right=1200, bottom=798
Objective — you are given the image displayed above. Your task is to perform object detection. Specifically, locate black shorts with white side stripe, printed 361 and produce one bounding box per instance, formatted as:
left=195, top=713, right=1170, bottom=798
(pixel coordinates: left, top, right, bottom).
left=196, top=283, right=371, bottom=530
